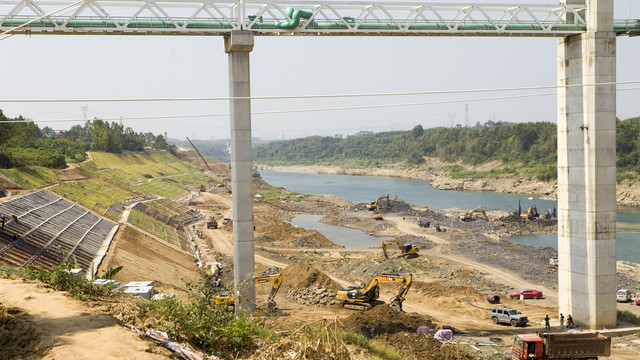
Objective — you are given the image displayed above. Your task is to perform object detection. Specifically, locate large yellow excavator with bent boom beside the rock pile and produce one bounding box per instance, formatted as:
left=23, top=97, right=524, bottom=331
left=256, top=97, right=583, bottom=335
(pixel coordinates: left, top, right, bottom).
left=336, top=274, right=413, bottom=311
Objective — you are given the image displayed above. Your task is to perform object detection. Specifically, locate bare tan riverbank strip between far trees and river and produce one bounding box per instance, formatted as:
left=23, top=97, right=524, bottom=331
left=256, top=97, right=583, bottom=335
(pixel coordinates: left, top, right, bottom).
left=256, top=160, right=640, bottom=207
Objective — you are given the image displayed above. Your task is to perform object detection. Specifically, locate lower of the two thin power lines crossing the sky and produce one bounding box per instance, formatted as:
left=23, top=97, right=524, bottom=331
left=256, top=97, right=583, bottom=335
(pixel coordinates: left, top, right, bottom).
left=0, top=87, right=640, bottom=124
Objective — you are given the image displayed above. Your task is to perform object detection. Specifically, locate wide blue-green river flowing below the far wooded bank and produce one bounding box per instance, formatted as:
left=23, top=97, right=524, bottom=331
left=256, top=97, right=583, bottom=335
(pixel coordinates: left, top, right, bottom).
left=260, top=170, right=640, bottom=263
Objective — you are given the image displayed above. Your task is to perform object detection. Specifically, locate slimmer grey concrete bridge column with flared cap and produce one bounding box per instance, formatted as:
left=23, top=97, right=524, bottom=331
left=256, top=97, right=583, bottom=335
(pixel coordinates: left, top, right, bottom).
left=224, top=31, right=256, bottom=313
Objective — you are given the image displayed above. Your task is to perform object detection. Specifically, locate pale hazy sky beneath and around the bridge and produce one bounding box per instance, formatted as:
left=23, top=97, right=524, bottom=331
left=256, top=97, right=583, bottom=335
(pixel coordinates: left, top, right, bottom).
left=0, top=0, right=640, bottom=139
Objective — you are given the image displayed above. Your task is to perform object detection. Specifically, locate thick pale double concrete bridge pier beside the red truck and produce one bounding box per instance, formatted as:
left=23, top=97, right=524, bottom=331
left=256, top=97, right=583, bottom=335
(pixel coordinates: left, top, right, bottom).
left=558, top=0, right=616, bottom=329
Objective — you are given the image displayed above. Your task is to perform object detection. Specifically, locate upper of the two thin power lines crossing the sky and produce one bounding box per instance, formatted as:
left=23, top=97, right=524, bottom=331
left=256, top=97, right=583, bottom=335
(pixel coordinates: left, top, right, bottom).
left=0, top=80, right=640, bottom=103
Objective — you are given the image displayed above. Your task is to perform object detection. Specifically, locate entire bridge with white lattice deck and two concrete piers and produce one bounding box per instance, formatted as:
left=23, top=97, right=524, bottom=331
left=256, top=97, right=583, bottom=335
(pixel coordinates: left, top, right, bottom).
left=0, top=0, right=640, bottom=329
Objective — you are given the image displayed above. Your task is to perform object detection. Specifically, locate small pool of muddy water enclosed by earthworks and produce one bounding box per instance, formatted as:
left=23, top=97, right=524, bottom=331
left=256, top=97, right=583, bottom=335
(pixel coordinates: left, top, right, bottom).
left=291, top=214, right=391, bottom=249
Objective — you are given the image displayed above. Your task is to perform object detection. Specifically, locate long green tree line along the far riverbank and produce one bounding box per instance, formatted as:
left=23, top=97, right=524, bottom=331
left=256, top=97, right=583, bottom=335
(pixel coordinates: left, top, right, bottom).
left=253, top=117, right=640, bottom=180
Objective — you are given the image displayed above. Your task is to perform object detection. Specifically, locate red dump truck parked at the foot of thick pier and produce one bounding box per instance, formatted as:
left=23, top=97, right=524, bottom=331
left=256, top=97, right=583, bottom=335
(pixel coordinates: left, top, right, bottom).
left=511, top=333, right=611, bottom=360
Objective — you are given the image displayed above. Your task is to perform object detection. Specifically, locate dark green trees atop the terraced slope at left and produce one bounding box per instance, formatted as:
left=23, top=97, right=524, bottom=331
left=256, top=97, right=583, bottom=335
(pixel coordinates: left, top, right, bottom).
left=0, top=110, right=176, bottom=169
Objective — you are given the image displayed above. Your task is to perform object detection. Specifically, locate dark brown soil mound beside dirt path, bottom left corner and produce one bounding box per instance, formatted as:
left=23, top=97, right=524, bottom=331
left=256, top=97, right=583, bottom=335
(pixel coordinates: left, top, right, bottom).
left=0, top=303, right=45, bottom=359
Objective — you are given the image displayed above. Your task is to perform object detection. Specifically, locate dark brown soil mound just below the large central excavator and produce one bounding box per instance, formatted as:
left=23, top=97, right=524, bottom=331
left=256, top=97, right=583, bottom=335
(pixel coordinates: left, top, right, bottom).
left=342, top=304, right=437, bottom=338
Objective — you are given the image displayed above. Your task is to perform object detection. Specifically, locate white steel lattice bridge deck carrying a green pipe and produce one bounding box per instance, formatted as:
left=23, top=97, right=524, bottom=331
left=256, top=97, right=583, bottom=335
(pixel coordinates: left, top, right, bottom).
left=0, top=0, right=640, bottom=37
